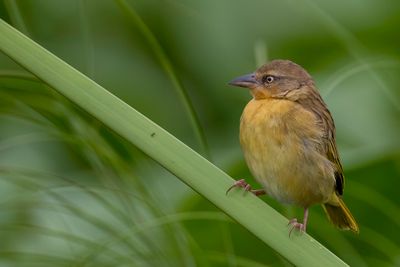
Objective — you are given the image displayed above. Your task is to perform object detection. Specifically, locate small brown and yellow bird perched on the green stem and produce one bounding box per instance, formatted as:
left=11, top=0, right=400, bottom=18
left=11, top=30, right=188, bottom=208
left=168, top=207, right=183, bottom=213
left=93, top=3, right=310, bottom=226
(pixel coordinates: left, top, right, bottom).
left=227, top=60, right=358, bottom=232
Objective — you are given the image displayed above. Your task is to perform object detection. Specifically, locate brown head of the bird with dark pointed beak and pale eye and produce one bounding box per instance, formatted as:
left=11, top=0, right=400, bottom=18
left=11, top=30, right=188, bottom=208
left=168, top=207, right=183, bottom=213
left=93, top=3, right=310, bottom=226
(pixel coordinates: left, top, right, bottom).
left=229, top=60, right=314, bottom=101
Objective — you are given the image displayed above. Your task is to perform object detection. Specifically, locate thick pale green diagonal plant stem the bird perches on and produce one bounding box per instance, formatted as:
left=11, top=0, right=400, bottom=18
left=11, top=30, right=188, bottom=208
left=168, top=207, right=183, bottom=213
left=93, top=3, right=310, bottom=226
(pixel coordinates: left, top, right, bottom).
left=0, top=20, right=346, bottom=266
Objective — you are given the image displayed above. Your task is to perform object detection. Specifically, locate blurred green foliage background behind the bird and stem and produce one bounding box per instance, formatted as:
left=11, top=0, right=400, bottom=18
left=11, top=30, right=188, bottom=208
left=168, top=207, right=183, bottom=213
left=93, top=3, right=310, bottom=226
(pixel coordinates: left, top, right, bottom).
left=0, top=0, right=400, bottom=266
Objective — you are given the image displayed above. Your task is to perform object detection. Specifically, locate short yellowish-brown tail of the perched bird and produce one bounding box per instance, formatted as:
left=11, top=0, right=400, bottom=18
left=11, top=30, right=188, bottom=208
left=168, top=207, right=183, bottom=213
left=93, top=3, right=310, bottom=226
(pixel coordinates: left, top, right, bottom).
left=322, top=197, right=359, bottom=233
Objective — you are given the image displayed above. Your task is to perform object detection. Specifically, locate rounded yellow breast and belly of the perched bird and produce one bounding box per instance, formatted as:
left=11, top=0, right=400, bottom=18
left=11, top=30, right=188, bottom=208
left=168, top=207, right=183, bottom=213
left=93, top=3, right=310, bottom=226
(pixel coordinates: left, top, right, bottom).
left=240, top=99, right=335, bottom=207
